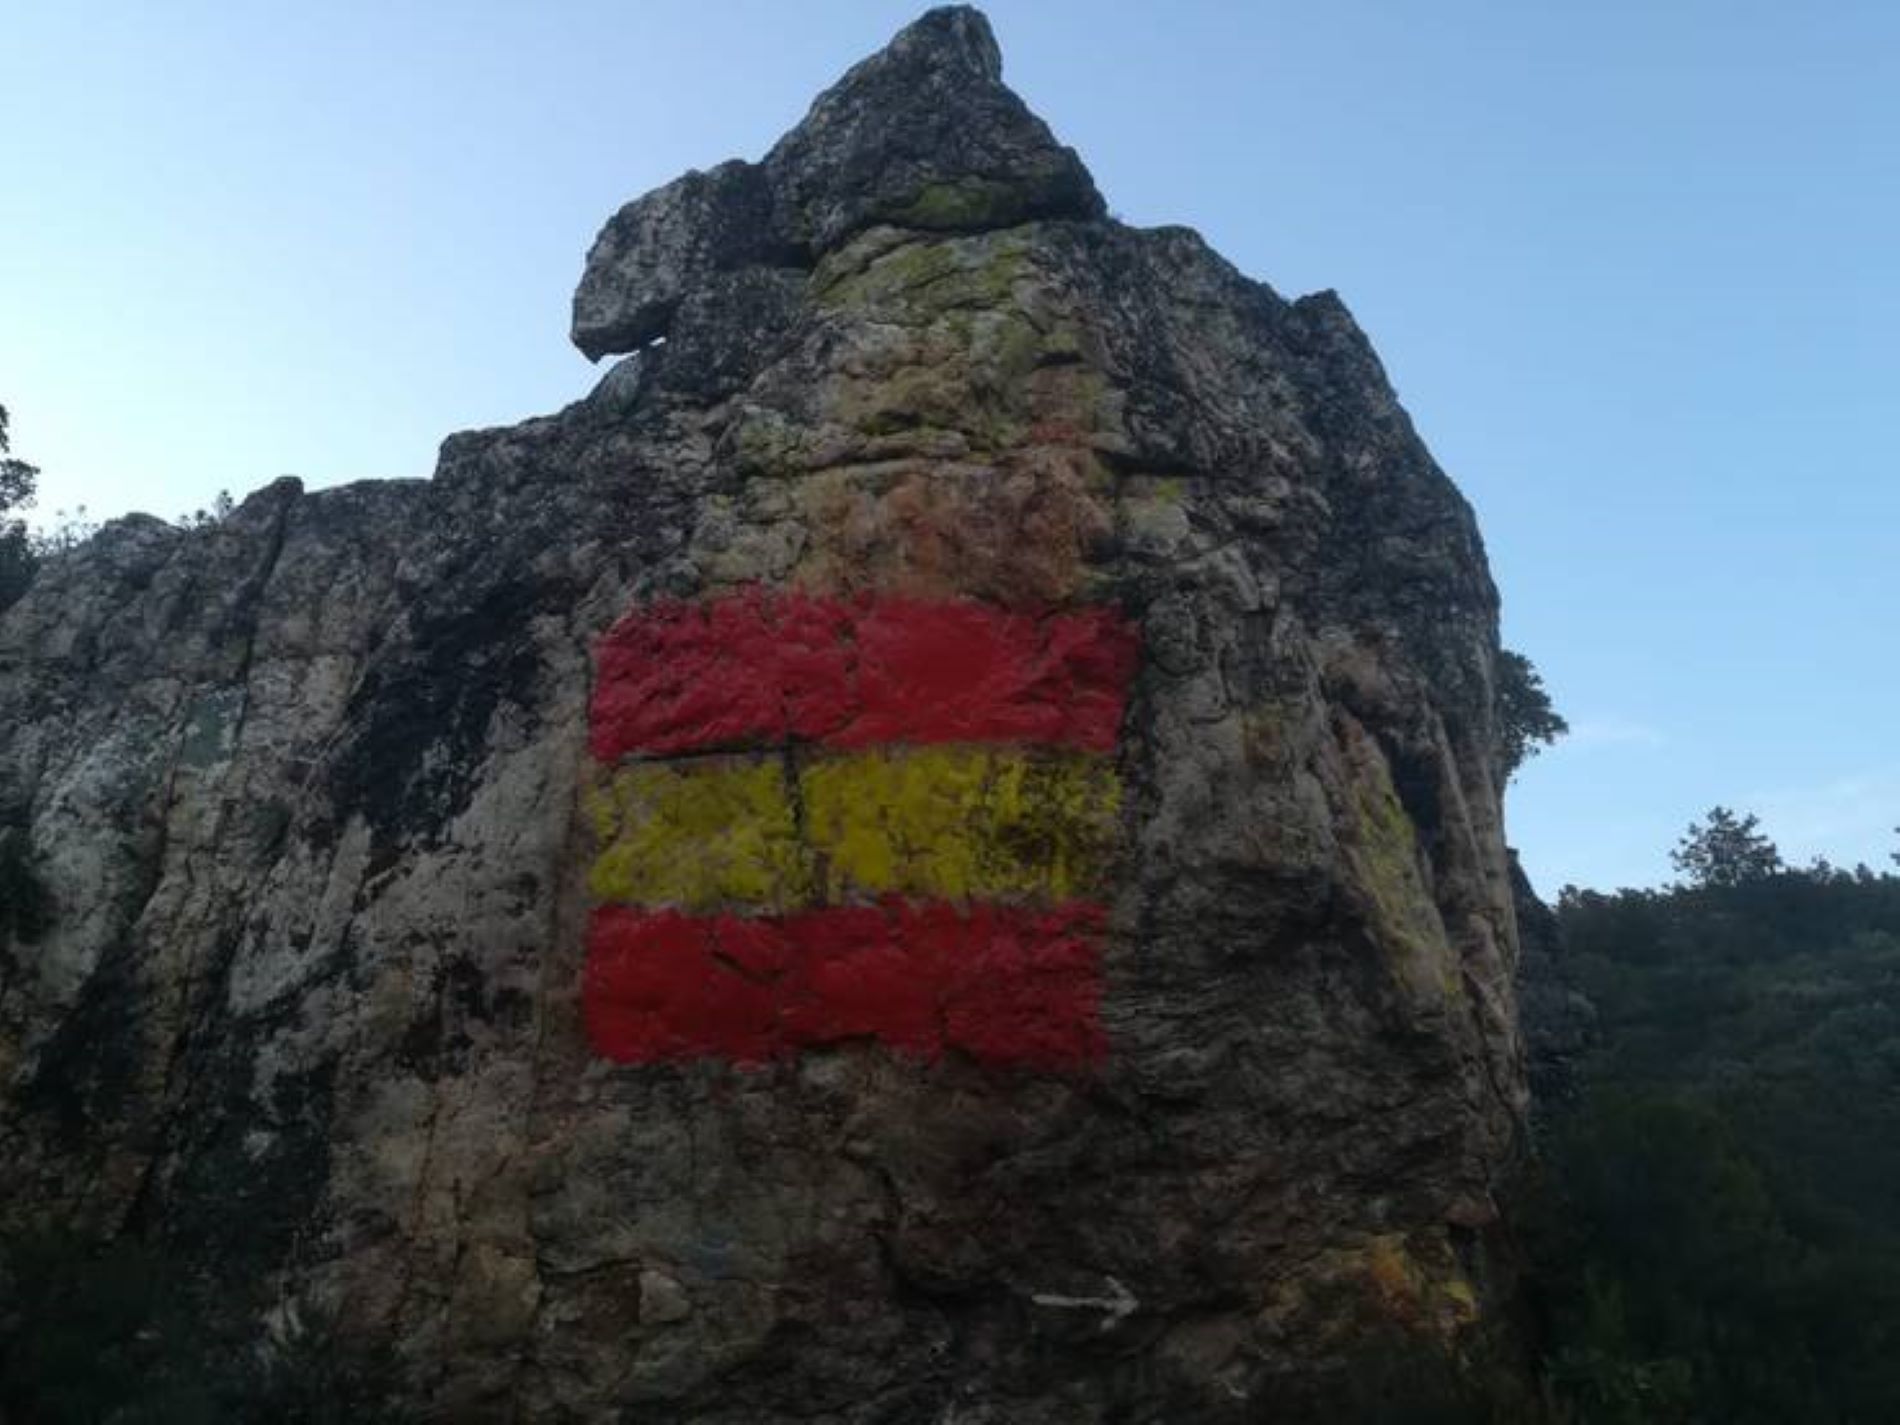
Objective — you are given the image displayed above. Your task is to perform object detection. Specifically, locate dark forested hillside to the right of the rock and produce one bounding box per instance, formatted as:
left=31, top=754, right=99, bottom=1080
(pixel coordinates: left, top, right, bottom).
left=1531, top=824, right=1900, bottom=1425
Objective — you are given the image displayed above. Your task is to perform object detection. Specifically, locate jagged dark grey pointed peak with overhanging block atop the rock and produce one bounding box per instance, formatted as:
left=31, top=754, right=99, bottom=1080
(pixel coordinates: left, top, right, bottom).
left=572, top=6, right=1104, bottom=359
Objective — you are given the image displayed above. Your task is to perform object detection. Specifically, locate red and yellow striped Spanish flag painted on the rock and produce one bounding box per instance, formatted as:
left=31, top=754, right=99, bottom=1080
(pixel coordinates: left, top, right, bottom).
left=583, top=589, right=1136, bottom=1068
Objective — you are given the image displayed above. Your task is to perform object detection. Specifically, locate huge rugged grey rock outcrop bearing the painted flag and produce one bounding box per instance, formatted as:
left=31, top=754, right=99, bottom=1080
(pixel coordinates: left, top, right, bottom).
left=0, top=10, right=1524, bottom=1425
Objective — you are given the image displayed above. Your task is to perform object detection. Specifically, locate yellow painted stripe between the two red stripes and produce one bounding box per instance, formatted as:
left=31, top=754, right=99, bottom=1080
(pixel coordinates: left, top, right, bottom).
left=589, top=747, right=1121, bottom=910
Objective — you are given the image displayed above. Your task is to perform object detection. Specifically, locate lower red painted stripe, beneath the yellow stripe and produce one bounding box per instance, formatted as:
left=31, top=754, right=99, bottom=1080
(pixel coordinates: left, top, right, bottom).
left=581, top=901, right=1106, bottom=1070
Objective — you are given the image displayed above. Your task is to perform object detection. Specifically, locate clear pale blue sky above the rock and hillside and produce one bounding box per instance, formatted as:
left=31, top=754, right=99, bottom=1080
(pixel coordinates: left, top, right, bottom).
left=0, top=0, right=1900, bottom=893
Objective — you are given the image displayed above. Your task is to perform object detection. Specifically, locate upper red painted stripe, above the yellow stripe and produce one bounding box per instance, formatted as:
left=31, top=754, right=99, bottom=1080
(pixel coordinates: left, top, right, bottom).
left=591, top=589, right=1136, bottom=762
